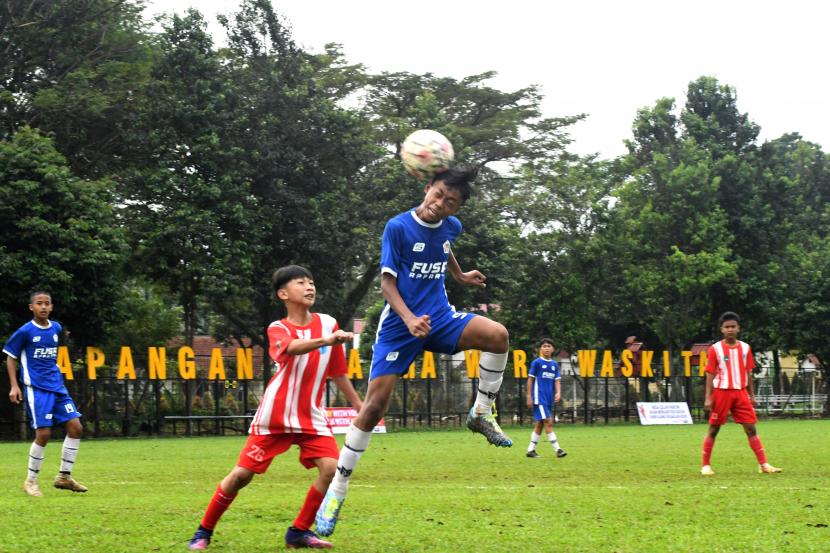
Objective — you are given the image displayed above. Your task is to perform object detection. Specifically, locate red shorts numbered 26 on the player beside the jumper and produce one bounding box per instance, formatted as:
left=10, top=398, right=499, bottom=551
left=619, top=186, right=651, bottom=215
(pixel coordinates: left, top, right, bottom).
left=236, top=434, right=340, bottom=474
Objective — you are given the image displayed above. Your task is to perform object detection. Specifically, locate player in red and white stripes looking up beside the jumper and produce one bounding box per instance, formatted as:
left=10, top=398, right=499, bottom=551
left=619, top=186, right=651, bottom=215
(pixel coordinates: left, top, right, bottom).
left=189, top=265, right=362, bottom=550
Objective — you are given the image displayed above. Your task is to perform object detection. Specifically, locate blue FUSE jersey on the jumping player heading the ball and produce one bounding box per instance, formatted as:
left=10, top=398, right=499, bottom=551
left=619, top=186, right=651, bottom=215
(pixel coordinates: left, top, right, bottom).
left=380, top=209, right=461, bottom=324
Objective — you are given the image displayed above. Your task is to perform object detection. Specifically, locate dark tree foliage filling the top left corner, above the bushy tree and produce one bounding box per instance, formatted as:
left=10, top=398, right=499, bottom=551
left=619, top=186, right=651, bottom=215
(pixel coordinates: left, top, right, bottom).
left=0, top=0, right=152, bottom=178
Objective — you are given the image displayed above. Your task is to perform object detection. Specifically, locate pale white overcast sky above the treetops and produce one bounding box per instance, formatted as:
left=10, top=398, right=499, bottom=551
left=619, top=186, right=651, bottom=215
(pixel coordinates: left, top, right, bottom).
left=146, top=0, right=830, bottom=158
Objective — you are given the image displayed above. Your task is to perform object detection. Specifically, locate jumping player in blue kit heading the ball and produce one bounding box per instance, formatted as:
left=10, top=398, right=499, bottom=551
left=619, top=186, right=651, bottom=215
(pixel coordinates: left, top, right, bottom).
left=316, top=169, right=513, bottom=536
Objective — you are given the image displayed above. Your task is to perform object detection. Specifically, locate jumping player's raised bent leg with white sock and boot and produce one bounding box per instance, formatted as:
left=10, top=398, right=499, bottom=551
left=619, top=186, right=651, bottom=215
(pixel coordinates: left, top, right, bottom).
left=458, top=317, right=513, bottom=447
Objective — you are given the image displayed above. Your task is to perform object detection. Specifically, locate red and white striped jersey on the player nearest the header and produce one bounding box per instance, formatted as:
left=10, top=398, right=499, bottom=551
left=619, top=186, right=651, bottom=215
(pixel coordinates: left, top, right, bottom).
left=250, top=313, right=347, bottom=436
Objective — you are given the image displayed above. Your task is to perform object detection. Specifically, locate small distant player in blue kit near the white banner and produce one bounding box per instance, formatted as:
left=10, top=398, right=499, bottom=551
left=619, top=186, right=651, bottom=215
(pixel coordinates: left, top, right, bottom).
left=527, top=338, right=567, bottom=457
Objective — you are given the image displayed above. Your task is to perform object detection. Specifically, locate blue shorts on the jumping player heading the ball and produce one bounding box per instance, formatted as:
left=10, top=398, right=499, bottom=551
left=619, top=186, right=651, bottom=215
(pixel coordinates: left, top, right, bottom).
left=369, top=305, right=477, bottom=380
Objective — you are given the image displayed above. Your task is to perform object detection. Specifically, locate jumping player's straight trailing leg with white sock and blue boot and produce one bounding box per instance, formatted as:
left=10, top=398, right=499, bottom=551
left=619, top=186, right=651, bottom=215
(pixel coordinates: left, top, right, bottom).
left=315, top=374, right=399, bottom=536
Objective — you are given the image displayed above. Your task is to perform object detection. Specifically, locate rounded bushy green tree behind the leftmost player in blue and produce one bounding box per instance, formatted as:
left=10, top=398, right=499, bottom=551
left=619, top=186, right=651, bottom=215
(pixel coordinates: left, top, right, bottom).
left=0, top=127, right=126, bottom=345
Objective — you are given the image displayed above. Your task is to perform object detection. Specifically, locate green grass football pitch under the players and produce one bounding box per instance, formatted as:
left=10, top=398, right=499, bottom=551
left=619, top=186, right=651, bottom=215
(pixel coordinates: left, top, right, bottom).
left=0, top=420, right=830, bottom=553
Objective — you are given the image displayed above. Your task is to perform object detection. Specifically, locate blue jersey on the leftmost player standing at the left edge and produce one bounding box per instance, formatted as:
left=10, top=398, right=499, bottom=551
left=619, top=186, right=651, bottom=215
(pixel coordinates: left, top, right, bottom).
left=3, top=321, right=66, bottom=393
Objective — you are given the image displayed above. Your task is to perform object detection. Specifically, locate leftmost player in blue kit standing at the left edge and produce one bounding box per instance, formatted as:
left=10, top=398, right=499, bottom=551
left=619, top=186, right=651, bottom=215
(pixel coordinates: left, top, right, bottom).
left=3, top=291, right=87, bottom=497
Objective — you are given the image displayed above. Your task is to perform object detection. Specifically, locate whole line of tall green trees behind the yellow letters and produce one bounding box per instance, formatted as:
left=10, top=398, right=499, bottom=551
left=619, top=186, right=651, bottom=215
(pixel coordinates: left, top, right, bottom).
left=0, top=0, right=830, bottom=396
